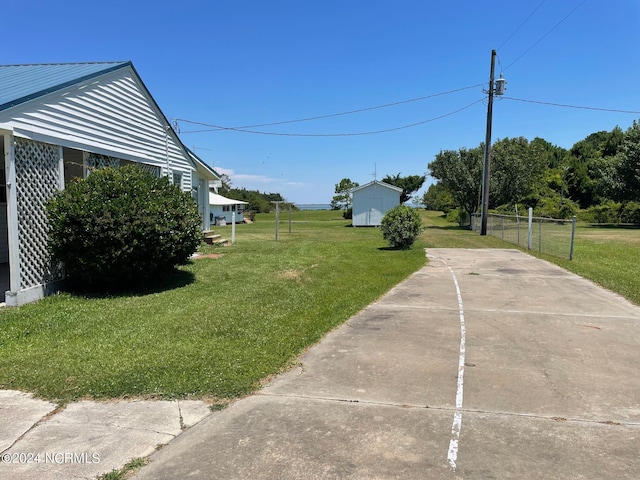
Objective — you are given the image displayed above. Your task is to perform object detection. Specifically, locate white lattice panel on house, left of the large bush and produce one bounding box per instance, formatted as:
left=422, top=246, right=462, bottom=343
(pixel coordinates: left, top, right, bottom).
left=15, top=138, right=62, bottom=289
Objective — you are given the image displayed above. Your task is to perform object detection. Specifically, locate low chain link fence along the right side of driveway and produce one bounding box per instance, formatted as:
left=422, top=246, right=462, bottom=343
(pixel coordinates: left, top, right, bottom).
left=471, top=212, right=576, bottom=260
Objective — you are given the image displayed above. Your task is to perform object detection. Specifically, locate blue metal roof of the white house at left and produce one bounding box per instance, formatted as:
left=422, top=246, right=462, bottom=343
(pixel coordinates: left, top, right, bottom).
left=0, top=62, right=131, bottom=110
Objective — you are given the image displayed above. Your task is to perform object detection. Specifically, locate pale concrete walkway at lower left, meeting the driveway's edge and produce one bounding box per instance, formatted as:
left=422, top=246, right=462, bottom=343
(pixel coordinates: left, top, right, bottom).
left=0, top=400, right=211, bottom=480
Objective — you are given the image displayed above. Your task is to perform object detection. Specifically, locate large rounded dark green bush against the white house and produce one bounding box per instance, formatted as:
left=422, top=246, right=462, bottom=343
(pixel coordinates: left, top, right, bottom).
left=47, top=165, right=201, bottom=291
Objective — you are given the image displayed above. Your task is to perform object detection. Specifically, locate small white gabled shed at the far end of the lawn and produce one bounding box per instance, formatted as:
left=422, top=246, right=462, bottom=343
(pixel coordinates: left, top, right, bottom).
left=351, top=180, right=402, bottom=227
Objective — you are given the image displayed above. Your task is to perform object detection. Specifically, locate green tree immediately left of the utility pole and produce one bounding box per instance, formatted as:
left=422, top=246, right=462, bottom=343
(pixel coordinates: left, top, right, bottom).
left=427, top=144, right=484, bottom=223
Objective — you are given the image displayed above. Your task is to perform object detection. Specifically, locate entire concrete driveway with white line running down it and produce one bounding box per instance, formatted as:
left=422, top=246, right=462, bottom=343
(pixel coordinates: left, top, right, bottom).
left=135, top=249, right=640, bottom=480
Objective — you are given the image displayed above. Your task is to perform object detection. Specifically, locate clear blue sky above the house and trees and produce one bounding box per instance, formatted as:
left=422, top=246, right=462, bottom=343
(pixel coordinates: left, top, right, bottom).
left=2, top=0, right=640, bottom=203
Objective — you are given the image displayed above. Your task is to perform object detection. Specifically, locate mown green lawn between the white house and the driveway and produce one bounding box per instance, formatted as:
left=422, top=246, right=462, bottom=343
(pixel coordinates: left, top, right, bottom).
left=0, top=211, right=426, bottom=403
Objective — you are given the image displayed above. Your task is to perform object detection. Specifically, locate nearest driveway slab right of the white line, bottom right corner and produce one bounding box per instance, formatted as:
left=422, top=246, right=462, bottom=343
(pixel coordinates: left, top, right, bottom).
left=456, top=413, right=640, bottom=480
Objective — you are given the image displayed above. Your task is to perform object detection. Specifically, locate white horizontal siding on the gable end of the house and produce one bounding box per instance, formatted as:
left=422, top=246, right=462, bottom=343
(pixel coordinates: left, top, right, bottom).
left=0, top=67, right=195, bottom=188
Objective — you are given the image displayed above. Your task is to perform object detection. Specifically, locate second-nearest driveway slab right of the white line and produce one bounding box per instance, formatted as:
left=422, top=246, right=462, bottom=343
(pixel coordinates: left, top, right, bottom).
left=465, top=311, right=640, bottom=423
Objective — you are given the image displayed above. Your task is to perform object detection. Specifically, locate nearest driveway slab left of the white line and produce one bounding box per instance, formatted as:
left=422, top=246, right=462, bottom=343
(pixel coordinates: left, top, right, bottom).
left=135, top=396, right=458, bottom=480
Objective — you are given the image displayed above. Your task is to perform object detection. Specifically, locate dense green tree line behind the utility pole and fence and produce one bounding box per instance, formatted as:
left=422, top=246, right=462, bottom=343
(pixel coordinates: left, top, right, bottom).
left=421, top=121, right=640, bottom=224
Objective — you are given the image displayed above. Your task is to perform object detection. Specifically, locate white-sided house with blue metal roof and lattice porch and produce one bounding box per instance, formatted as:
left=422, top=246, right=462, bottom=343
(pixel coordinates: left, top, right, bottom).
left=0, top=62, right=219, bottom=305
